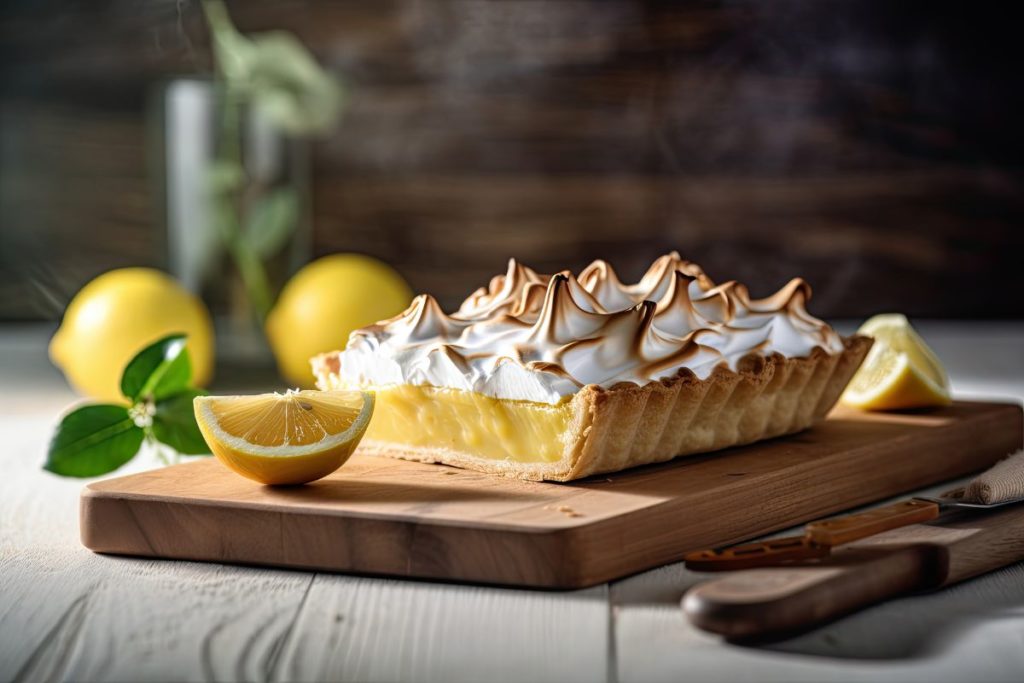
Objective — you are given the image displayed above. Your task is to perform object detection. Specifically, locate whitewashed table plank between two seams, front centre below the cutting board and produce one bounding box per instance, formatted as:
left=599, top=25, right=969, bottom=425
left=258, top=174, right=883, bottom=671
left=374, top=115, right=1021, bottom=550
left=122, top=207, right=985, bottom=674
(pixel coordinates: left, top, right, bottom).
left=270, top=573, right=609, bottom=683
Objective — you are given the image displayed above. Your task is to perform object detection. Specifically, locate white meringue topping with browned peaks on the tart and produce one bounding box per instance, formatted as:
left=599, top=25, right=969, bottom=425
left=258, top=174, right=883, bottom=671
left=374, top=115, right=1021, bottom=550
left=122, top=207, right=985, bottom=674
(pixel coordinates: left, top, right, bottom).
left=331, top=252, right=843, bottom=403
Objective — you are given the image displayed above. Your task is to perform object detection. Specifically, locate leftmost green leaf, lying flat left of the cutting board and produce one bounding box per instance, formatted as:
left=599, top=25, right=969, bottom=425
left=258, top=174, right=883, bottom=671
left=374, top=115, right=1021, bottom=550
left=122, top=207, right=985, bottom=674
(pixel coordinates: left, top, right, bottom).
left=43, top=405, right=144, bottom=477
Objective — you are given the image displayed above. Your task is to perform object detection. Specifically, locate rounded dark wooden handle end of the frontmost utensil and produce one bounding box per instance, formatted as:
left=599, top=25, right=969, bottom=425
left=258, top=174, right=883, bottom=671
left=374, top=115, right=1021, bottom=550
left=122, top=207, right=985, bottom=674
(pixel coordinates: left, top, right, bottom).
left=682, top=545, right=935, bottom=640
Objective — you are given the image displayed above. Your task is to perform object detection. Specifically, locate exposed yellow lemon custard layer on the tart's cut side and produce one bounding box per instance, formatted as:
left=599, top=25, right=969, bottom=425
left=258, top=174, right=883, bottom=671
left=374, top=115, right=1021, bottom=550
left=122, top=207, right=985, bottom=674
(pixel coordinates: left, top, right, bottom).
left=367, top=384, right=572, bottom=463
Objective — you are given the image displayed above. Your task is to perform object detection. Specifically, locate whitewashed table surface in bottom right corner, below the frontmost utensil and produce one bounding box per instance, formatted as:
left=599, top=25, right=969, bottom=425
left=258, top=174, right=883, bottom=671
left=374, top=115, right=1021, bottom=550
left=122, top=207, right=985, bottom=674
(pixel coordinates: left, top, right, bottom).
left=611, top=564, right=1024, bottom=683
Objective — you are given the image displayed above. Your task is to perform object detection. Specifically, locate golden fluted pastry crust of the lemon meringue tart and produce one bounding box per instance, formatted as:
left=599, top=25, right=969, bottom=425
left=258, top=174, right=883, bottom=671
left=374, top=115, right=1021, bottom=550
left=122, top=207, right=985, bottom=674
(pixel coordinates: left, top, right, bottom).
left=313, top=335, right=872, bottom=481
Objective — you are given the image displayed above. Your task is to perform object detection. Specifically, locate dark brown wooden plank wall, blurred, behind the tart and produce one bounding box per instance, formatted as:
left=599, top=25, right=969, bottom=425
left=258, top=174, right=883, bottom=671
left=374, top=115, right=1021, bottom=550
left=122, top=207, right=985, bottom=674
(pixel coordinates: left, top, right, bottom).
left=0, top=0, right=1024, bottom=318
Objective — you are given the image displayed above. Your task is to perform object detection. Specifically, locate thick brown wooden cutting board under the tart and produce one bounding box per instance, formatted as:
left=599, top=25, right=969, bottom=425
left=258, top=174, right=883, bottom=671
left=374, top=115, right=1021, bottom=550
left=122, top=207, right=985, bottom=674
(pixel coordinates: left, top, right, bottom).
left=81, top=402, right=1024, bottom=588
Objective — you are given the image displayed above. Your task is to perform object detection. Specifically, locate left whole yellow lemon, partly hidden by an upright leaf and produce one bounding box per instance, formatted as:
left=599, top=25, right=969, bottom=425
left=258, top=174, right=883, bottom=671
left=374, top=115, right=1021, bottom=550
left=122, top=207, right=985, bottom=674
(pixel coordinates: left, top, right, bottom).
left=50, top=268, right=213, bottom=401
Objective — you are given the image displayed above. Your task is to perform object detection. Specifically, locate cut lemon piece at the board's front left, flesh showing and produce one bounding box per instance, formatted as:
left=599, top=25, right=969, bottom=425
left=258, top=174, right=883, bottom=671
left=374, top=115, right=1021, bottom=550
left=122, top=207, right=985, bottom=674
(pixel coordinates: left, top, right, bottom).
left=194, top=391, right=374, bottom=484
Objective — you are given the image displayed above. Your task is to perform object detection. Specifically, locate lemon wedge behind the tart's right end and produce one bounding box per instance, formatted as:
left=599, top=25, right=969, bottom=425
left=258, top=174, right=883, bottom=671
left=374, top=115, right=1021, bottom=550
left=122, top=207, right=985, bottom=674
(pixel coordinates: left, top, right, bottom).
left=843, top=313, right=952, bottom=411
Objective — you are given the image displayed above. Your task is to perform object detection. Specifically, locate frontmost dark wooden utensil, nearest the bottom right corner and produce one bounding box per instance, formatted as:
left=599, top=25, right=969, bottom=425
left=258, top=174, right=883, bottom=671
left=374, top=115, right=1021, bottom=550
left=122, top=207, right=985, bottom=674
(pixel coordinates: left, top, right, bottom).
left=682, top=505, right=1024, bottom=640
